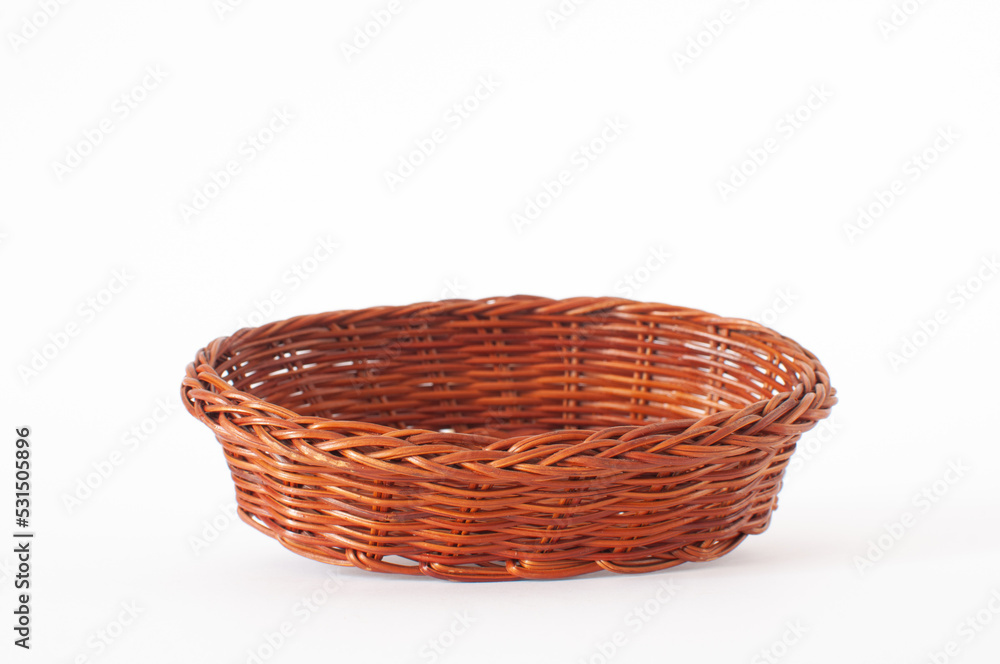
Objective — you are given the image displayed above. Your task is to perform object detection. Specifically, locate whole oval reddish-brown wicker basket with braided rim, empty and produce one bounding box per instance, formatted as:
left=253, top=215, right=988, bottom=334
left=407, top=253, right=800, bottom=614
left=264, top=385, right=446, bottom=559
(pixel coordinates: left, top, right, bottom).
left=182, top=295, right=837, bottom=581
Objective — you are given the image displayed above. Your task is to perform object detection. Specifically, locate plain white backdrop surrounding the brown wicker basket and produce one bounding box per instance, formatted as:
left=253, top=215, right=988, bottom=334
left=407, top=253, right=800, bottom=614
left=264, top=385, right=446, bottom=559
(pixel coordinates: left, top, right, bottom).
left=0, top=0, right=1000, bottom=664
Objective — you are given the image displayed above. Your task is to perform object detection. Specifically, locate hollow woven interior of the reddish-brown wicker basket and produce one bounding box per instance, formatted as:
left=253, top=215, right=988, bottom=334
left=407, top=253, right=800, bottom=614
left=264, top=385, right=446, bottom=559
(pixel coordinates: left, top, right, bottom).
left=216, top=310, right=802, bottom=436
